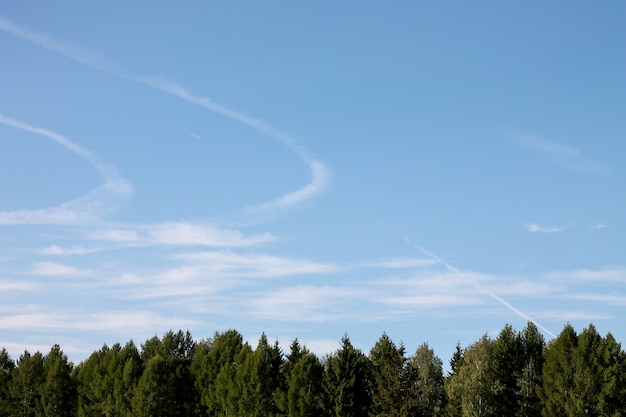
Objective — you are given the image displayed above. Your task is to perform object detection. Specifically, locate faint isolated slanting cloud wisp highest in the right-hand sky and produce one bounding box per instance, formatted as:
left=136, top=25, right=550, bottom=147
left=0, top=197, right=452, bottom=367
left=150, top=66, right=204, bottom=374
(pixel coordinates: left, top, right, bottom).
left=509, top=133, right=610, bottom=175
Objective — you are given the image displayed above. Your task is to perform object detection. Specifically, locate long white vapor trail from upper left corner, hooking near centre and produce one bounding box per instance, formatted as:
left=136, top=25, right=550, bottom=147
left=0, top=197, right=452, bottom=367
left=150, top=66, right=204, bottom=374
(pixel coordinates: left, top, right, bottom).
left=0, top=17, right=330, bottom=216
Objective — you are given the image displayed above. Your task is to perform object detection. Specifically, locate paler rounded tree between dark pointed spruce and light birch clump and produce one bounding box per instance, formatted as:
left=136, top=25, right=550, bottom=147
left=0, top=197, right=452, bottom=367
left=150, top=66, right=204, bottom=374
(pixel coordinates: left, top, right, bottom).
left=403, top=343, right=445, bottom=417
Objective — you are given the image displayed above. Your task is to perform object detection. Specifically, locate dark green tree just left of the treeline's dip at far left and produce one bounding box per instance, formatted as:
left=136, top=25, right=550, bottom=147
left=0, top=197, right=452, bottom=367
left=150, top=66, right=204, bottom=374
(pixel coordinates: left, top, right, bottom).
left=41, top=345, right=78, bottom=417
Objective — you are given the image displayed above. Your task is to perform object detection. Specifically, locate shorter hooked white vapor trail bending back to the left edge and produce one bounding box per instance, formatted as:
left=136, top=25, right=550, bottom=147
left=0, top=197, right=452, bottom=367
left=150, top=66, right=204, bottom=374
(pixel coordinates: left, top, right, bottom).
left=0, top=113, right=133, bottom=225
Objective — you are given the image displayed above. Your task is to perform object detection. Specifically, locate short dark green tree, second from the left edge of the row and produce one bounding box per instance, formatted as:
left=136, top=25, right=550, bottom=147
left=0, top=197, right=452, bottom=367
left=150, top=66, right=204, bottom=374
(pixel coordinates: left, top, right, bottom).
left=9, top=351, right=46, bottom=417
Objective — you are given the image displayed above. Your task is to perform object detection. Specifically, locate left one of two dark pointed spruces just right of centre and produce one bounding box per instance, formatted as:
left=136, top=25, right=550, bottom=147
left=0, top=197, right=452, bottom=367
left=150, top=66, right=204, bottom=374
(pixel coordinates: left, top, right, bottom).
left=324, top=335, right=372, bottom=417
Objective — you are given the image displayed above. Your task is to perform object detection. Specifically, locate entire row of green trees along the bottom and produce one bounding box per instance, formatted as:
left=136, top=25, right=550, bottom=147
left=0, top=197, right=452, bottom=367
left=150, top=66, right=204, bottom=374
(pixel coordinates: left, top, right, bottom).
left=0, top=323, right=626, bottom=417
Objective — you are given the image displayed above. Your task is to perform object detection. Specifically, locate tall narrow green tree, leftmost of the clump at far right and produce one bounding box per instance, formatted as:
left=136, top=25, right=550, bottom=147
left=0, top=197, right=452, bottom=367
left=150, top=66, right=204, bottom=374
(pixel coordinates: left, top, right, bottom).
left=540, top=324, right=579, bottom=417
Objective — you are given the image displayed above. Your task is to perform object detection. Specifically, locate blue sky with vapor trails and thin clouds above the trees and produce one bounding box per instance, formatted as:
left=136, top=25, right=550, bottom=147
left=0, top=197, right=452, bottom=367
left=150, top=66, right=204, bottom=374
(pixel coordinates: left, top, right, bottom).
left=0, top=1, right=626, bottom=361
